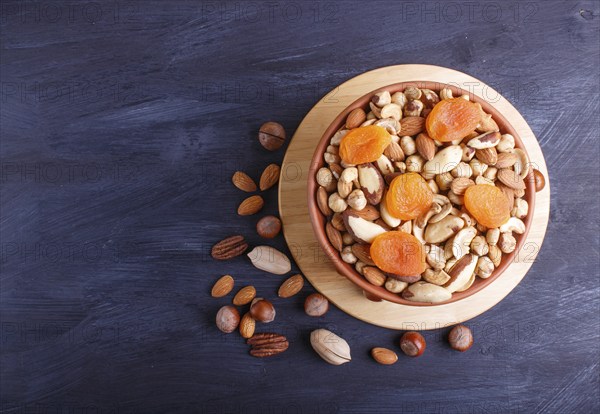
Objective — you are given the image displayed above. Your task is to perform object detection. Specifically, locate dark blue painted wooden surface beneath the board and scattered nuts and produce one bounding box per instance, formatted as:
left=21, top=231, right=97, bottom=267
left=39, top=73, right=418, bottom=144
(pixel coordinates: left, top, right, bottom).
left=0, top=0, right=600, bottom=414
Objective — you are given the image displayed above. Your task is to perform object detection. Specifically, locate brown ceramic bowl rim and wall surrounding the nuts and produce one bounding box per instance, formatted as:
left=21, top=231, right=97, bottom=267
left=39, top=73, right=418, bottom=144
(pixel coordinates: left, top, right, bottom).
left=308, top=81, right=535, bottom=306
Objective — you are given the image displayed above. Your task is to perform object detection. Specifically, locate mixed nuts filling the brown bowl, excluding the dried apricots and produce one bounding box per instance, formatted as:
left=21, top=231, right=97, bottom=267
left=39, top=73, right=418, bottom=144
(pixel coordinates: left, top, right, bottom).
left=316, top=87, right=544, bottom=303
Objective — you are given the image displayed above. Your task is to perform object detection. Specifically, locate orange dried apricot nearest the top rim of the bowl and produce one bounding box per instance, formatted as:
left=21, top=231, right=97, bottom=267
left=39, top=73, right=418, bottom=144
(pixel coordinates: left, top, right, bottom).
left=425, top=98, right=481, bottom=142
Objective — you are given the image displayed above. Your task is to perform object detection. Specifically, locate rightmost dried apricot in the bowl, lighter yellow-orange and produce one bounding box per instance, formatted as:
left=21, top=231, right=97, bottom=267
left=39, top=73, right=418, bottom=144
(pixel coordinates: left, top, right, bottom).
left=465, top=184, right=510, bottom=229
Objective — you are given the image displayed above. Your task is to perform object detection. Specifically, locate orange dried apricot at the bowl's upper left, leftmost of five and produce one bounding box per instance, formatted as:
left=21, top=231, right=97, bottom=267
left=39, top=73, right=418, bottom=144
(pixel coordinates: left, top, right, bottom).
left=340, top=125, right=392, bottom=164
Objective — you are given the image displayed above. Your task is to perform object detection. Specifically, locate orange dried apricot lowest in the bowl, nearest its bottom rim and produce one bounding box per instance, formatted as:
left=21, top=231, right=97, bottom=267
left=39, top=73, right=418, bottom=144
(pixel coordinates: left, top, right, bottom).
left=370, top=231, right=426, bottom=276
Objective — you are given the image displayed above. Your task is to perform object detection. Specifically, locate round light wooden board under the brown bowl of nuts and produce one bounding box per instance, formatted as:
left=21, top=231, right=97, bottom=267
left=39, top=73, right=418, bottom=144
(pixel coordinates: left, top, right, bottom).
left=279, top=65, right=550, bottom=330
